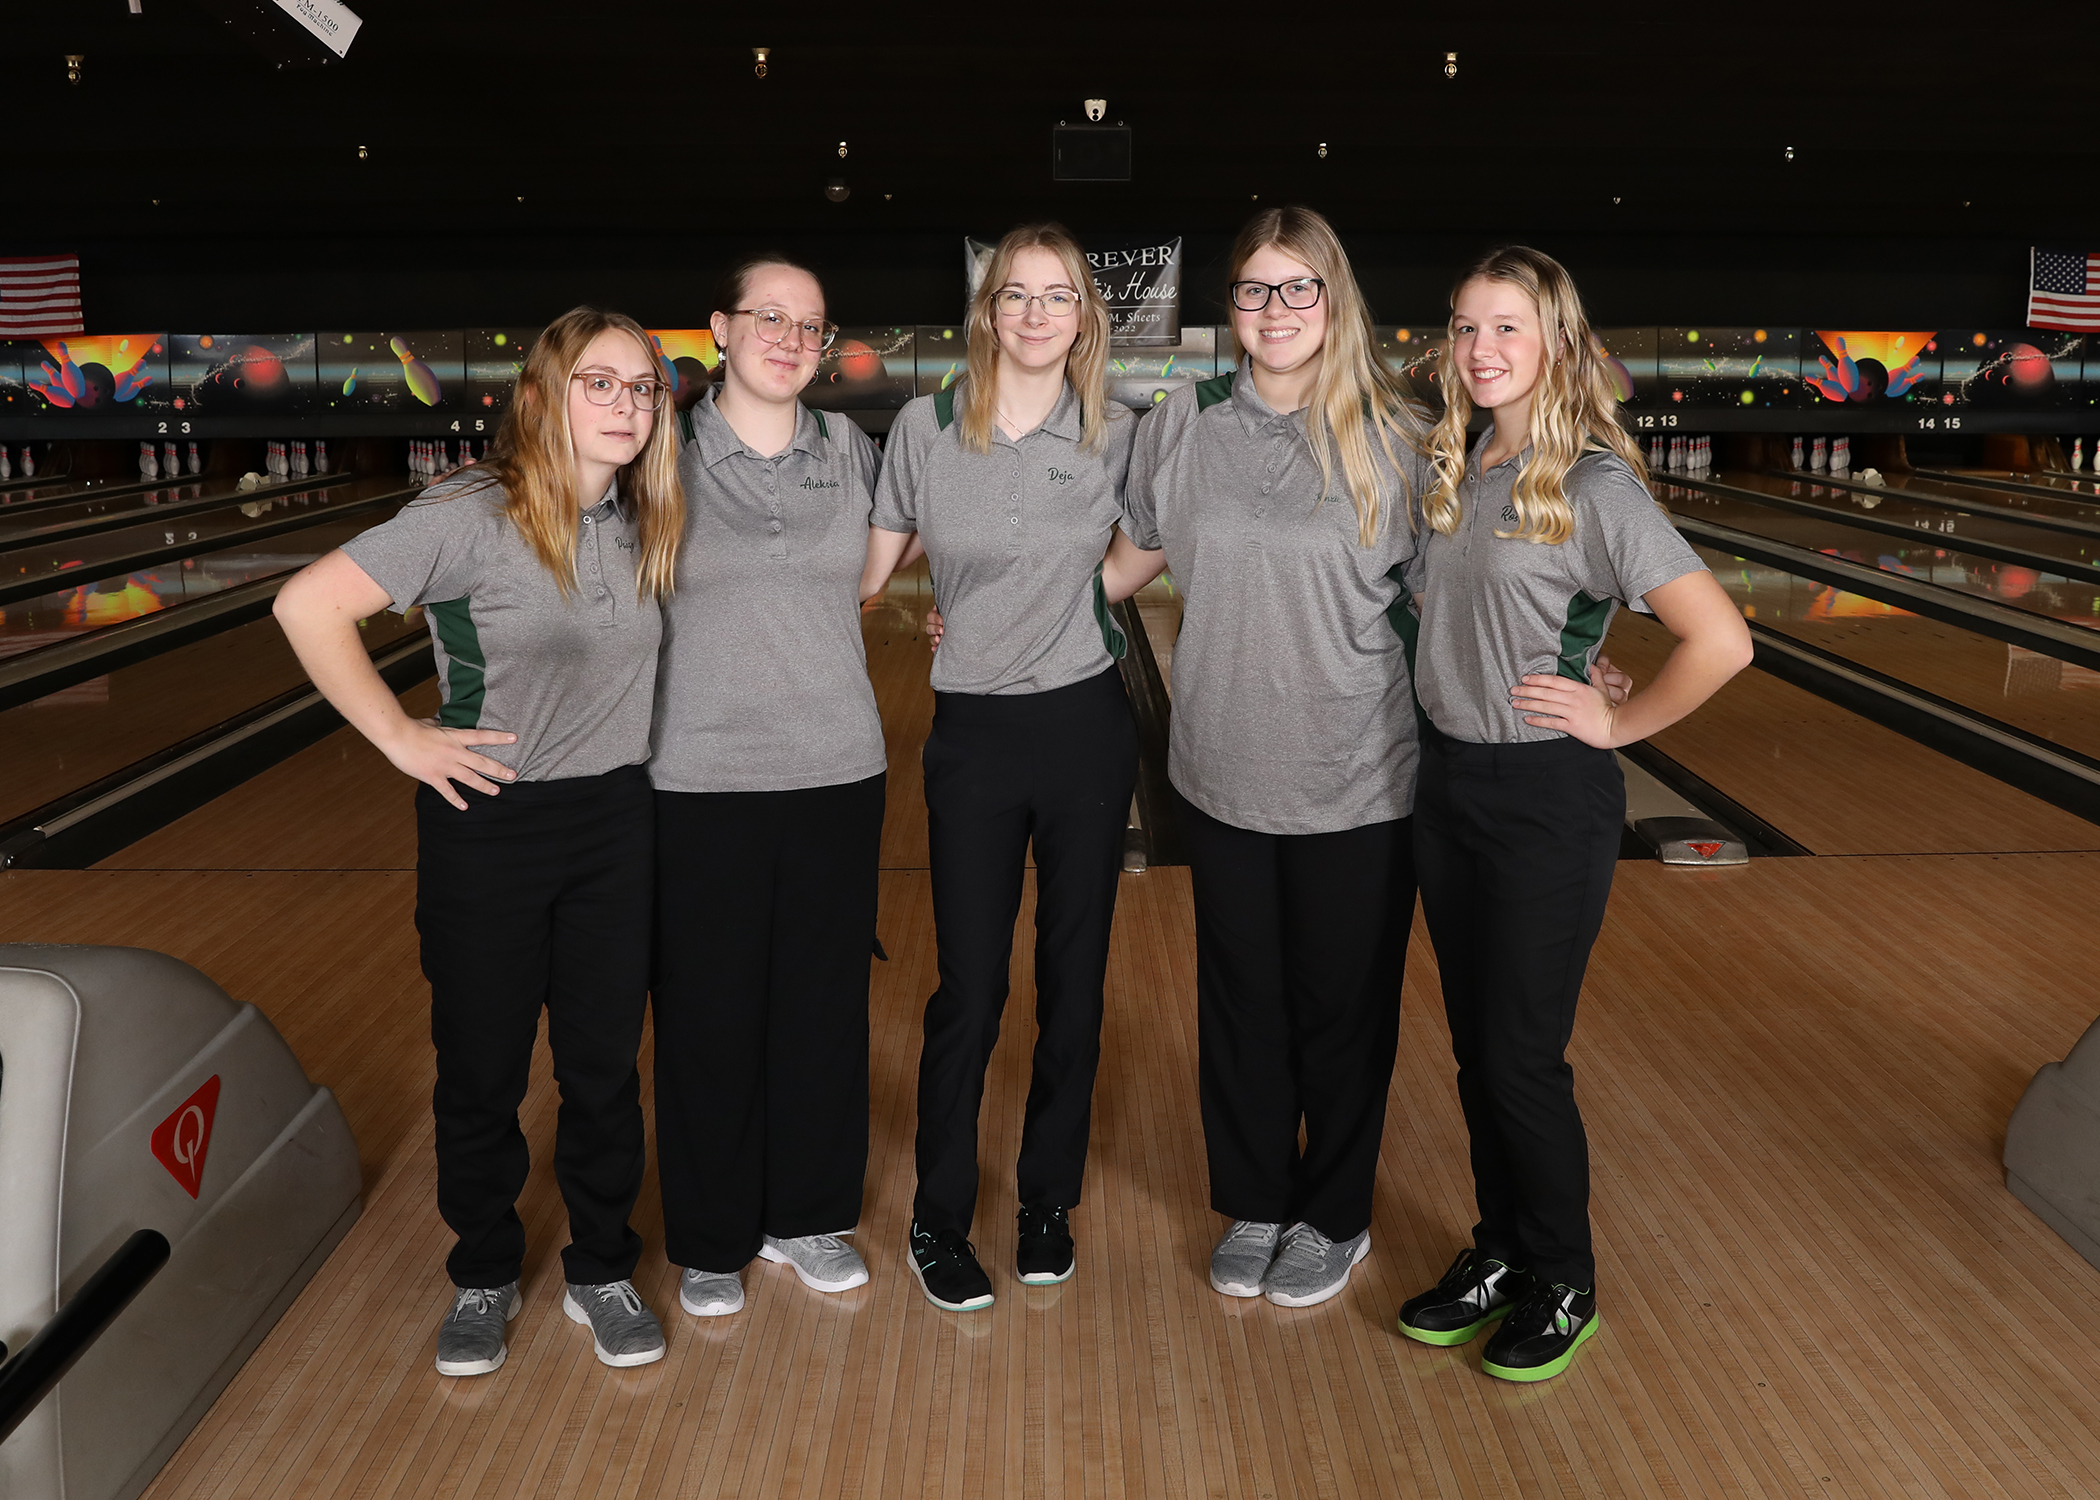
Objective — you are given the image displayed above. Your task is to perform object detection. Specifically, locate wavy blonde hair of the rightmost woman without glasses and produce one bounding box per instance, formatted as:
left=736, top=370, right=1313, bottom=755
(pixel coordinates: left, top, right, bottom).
left=1422, top=246, right=1649, bottom=546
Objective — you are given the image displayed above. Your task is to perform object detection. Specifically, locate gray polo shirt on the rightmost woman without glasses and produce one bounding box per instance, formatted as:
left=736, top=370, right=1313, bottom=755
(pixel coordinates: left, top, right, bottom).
left=1409, top=429, right=1705, bottom=744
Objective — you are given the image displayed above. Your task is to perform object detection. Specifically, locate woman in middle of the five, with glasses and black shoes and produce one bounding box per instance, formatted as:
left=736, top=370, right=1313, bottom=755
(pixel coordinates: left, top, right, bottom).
left=861, top=225, right=1157, bottom=1311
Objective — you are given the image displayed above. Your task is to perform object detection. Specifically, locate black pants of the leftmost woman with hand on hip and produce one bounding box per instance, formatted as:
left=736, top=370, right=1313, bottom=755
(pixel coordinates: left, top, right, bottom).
left=416, top=765, right=655, bottom=1286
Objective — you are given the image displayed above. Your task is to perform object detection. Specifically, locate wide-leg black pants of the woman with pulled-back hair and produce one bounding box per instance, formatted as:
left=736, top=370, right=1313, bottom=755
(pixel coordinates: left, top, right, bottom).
left=653, top=775, right=884, bottom=1271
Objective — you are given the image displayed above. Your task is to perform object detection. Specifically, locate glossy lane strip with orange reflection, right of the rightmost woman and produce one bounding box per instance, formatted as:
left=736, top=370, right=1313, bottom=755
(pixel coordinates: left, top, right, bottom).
left=1655, top=479, right=2100, bottom=630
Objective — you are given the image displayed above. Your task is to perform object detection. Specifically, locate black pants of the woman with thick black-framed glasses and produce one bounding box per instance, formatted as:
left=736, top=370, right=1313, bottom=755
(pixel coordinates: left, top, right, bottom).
left=1178, top=798, right=1415, bottom=1239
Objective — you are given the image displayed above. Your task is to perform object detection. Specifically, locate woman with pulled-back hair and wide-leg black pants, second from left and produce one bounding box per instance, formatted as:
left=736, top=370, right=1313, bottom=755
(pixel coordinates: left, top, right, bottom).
left=649, top=256, right=886, bottom=1317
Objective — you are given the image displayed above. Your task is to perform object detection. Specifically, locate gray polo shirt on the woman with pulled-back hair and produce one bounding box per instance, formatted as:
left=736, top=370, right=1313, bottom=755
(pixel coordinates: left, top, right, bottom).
left=649, top=391, right=884, bottom=792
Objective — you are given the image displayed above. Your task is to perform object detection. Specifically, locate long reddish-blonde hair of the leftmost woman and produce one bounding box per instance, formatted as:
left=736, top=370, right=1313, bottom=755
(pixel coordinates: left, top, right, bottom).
left=468, top=307, right=685, bottom=599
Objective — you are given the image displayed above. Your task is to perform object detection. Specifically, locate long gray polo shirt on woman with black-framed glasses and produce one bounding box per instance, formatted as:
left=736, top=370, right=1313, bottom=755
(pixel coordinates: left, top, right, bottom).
left=1125, top=363, right=1426, bottom=834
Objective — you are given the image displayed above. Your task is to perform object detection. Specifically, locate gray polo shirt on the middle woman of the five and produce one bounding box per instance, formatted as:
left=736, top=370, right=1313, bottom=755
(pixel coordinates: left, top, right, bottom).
left=876, top=384, right=1138, bottom=693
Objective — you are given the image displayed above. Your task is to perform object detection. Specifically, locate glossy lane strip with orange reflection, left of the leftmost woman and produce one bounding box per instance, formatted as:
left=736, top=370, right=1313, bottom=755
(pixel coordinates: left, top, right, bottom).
left=0, top=495, right=413, bottom=655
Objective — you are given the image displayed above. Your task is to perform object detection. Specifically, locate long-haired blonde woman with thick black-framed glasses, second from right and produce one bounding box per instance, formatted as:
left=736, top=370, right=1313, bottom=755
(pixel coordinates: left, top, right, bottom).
left=1117, top=208, right=1428, bottom=1307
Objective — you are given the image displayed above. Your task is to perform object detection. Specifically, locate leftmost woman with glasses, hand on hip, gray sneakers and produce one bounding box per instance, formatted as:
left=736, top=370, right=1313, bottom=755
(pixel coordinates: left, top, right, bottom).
left=277, top=307, right=685, bottom=1376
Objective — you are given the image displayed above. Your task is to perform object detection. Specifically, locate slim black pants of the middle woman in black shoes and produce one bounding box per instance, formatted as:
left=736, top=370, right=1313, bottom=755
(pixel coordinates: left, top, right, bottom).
left=911, top=666, right=1138, bottom=1235
